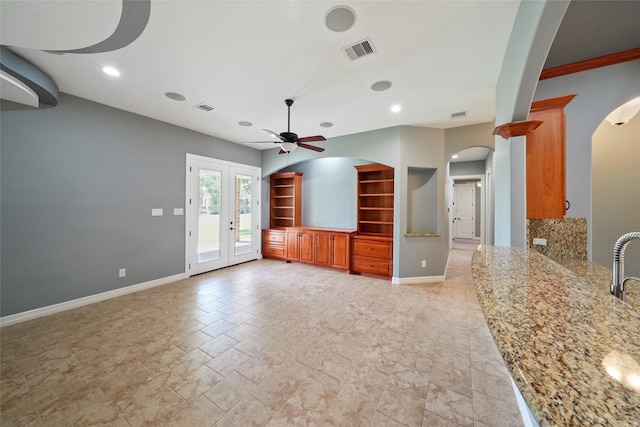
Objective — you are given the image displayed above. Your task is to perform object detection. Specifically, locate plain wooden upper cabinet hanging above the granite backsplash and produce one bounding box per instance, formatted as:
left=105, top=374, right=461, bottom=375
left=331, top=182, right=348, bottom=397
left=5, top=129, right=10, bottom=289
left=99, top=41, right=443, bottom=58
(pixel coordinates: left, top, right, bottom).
left=526, top=95, right=576, bottom=219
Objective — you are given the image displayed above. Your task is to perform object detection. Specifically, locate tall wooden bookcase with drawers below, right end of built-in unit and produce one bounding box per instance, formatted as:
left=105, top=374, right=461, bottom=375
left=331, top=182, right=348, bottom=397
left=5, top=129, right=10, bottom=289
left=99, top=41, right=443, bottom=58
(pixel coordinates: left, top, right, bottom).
left=351, top=164, right=394, bottom=278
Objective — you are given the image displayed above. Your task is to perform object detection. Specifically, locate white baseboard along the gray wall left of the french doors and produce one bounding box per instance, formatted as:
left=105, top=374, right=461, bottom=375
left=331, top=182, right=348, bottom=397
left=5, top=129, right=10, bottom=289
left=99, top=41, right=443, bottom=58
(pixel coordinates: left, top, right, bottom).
left=0, top=273, right=187, bottom=328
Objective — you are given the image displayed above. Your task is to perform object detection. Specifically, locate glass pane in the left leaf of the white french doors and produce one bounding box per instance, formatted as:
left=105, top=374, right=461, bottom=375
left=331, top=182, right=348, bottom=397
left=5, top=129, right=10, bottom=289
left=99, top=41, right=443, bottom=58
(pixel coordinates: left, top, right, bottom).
left=198, top=169, right=222, bottom=263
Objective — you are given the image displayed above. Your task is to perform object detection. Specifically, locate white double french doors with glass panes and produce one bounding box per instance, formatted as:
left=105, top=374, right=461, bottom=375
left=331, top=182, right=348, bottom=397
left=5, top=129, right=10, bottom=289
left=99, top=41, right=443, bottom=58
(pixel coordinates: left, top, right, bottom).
left=185, top=154, right=260, bottom=276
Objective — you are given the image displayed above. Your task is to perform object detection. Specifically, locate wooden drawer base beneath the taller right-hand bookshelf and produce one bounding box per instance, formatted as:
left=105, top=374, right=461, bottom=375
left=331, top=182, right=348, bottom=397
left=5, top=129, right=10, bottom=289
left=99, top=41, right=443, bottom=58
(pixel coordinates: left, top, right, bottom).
left=351, top=235, right=393, bottom=277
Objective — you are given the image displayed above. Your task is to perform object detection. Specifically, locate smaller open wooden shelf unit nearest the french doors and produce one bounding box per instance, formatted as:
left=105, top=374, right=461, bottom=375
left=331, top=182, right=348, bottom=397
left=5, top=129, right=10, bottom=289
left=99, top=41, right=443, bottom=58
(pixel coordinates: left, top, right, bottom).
left=269, top=172, right=302, bottom=228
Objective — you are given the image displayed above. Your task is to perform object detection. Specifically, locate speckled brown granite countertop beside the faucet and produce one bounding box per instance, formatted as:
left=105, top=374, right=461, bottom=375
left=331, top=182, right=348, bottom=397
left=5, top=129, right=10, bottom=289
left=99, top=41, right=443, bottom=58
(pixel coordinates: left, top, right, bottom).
left=472, top=246, right=640, bottom=426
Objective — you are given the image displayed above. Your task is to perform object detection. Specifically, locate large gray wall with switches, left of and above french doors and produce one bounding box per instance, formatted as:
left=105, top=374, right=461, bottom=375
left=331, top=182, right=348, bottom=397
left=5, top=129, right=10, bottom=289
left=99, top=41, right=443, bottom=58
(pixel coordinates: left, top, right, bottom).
left=0, top=94, right=261, bottom=316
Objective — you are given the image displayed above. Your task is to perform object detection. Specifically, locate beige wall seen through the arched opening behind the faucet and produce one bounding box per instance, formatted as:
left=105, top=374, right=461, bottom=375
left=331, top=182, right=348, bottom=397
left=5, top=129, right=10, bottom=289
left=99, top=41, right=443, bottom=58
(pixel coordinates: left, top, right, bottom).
left=593, top=114, right=640, bottom=276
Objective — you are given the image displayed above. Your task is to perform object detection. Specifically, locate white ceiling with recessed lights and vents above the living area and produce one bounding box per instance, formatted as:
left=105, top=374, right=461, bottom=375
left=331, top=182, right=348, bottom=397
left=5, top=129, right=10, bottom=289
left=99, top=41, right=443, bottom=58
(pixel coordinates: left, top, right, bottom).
left=0, top=0, right=519, bottom=149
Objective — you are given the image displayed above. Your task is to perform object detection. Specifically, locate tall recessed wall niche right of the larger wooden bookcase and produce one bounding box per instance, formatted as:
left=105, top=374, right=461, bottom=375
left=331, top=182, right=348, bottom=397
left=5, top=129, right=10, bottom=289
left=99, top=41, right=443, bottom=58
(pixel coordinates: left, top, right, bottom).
left=407, top=167, right=438, bottom=236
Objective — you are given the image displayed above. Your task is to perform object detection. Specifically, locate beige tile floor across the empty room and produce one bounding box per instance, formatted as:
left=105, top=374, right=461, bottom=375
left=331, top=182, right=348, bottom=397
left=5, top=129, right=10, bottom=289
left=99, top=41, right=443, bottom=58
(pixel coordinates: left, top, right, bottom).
left=0, top=250, right=522, bottom=427
